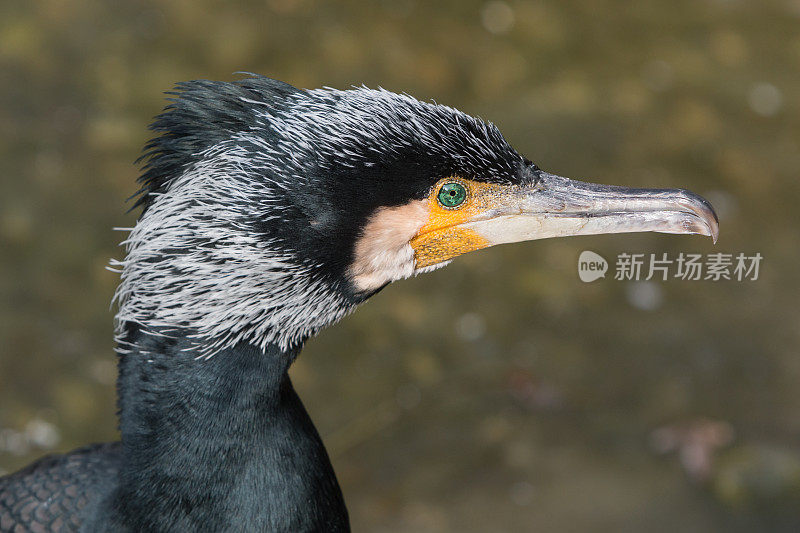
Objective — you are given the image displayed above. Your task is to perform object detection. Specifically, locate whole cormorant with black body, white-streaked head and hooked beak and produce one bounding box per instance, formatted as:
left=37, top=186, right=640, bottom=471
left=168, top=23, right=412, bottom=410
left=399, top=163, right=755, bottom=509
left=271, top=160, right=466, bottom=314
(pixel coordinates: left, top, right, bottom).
left=0, top=76, right=718, bottom=532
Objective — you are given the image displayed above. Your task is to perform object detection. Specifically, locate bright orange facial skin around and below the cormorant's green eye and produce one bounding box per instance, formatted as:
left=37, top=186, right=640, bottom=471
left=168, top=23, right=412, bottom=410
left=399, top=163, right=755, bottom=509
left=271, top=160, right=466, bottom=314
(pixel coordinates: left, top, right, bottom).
left=409, top=178, right=508, bottom=268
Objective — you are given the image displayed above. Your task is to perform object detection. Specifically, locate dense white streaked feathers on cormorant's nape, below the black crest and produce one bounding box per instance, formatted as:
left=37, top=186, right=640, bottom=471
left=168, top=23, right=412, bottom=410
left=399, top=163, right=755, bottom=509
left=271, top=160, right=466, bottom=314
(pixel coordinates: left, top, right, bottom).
left=112, top=144, right=351, bottom=356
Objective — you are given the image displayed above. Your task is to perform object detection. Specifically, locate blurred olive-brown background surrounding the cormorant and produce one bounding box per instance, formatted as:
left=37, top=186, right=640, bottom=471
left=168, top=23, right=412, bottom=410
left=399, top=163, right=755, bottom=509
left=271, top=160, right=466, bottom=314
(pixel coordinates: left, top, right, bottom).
left=0, top=0, right=800, bottom=532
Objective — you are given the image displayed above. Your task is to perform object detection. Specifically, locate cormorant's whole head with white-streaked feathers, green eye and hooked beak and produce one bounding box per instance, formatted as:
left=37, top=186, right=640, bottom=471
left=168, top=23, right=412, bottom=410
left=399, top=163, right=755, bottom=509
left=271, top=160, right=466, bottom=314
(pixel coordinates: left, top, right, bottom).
left=117, top=77, right=718, bottom=355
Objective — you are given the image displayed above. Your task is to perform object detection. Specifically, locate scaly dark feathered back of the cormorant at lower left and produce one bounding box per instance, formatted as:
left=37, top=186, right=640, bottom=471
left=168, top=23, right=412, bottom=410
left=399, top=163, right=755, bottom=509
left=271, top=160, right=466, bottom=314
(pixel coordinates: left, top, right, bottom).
left=0, top=443, right=121, bottom=533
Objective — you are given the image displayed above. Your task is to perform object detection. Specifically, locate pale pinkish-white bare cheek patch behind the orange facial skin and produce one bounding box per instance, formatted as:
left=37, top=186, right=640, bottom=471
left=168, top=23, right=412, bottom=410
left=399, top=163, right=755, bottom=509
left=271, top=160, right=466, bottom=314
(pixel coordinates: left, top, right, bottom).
left=348, top=200, right=429, bottom=292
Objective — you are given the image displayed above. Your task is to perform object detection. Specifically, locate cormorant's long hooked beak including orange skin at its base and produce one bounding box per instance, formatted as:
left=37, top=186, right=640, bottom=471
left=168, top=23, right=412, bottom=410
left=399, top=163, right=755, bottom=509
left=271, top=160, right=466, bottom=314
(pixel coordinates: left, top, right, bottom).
left=411, top=172, right=719, bottom=268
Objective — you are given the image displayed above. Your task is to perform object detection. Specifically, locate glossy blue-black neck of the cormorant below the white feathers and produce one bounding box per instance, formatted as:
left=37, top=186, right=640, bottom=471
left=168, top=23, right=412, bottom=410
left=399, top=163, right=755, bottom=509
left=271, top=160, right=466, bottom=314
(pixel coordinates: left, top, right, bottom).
left=103, top=331, right=348, bottom=531
